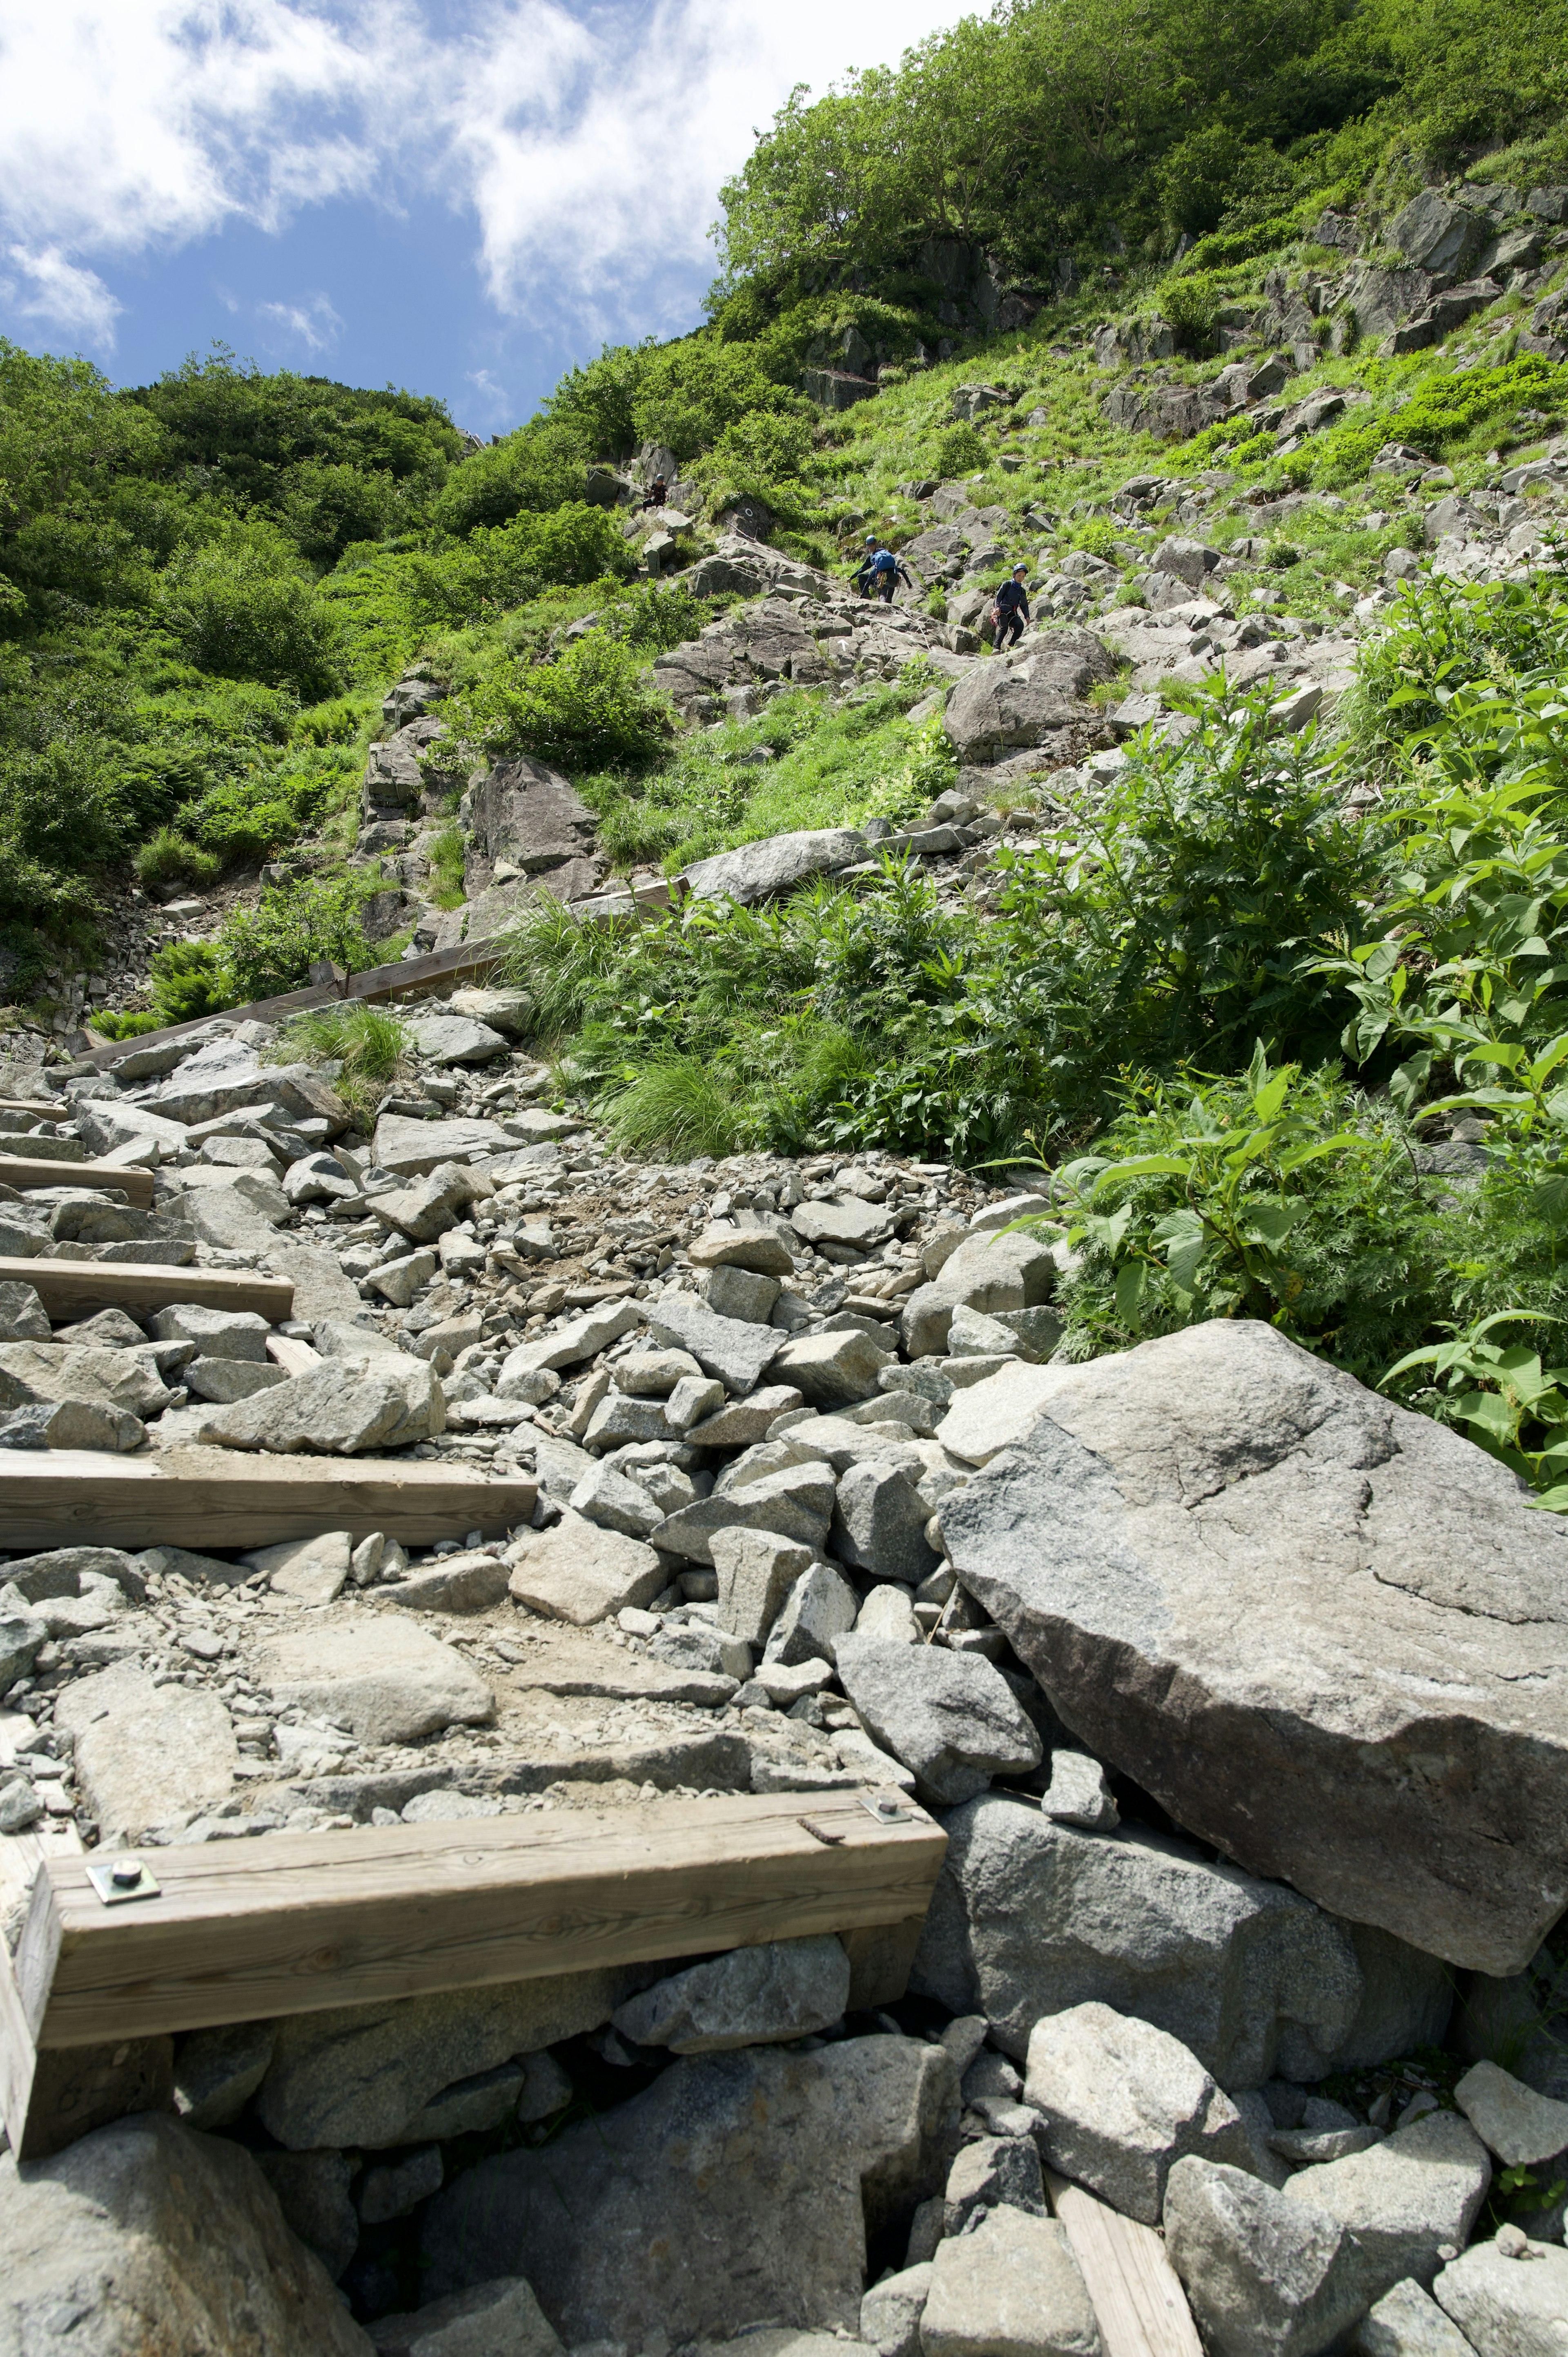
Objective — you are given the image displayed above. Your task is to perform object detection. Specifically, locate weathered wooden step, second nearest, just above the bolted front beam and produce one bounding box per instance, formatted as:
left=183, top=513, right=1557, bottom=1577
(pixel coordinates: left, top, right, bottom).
left=0, top=1442, right=538, bottom=1553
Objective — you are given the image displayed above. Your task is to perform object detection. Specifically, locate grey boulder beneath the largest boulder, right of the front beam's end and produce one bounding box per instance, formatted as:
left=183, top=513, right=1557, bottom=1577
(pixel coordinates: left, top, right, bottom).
left=910, top=1794, right=1446, bottom=2093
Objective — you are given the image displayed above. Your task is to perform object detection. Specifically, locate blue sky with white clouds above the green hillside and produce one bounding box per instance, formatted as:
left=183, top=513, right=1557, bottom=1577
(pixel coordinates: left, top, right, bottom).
left=0, top=0, right=964, bottom=434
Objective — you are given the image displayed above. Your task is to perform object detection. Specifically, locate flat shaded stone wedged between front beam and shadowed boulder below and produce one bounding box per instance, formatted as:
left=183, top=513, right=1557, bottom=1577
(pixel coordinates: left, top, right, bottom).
left=613, top=1933, right=849, bottom=2055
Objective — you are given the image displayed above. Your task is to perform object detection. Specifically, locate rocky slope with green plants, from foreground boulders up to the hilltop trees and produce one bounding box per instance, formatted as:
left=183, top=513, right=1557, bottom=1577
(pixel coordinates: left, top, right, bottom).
left=0, top=46, right=1568, bottom=2357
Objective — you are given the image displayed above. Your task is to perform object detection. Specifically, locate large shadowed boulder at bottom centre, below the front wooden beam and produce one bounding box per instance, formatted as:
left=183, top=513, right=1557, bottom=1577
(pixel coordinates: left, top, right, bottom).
left=422, top=2036, right=957, bottom=2350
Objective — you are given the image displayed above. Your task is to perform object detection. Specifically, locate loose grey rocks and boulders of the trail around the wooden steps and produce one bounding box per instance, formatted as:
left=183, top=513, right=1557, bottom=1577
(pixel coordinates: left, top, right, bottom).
left=0, top=966, right=1568, bottom=2357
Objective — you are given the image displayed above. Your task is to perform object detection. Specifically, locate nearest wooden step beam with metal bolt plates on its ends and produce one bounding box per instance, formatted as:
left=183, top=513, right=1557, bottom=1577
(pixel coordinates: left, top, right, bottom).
left=16, top=1791, right=948, bottom=2048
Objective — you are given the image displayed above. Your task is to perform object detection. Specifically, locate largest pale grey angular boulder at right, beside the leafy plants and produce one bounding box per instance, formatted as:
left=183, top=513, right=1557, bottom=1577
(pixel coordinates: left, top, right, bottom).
left=941, top=1320, right=1568, bottom=1973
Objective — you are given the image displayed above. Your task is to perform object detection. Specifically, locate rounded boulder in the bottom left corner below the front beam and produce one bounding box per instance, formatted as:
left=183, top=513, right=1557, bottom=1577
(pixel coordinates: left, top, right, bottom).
left=0, top=2112, right=372, bottom=2357
